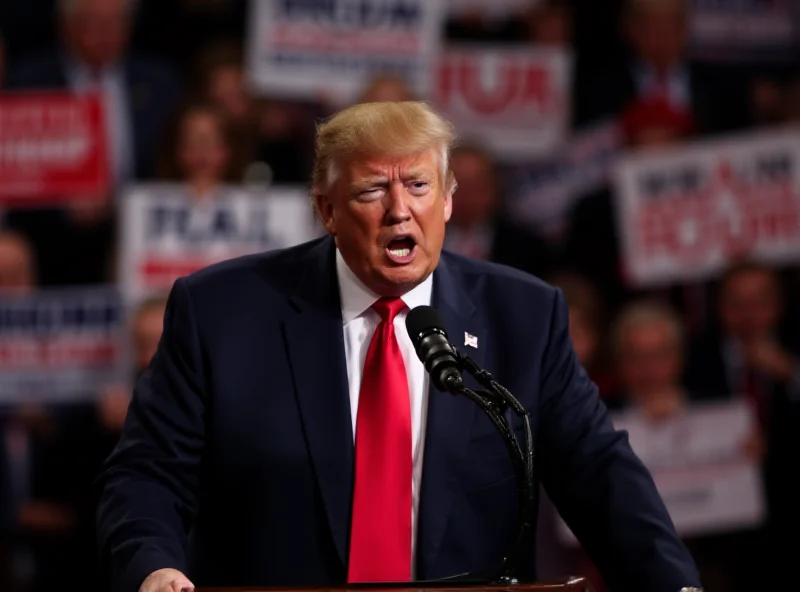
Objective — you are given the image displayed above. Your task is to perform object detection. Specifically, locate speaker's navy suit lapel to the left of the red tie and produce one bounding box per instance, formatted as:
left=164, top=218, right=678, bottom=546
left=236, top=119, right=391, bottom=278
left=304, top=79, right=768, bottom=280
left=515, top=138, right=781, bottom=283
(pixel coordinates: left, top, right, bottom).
left=283, top=239, right=353, bottom=565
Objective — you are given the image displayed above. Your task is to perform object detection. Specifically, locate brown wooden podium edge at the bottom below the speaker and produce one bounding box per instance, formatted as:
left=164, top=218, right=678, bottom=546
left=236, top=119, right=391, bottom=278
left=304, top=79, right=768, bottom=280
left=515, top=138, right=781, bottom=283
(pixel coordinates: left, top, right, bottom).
left=196, top=577, right=592, bottom=592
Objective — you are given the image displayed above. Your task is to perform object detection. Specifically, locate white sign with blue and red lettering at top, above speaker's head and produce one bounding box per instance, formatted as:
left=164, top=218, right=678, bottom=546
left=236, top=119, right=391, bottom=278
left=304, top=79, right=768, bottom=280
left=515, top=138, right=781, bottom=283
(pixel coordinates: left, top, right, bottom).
left=248, top=0, right=445, bottom=102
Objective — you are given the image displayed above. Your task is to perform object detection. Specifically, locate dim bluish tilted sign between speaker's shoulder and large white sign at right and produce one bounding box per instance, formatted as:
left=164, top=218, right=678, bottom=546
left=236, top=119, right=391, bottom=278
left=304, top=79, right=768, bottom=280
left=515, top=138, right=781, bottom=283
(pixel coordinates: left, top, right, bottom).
left=504, top=121, right=622, bottom=243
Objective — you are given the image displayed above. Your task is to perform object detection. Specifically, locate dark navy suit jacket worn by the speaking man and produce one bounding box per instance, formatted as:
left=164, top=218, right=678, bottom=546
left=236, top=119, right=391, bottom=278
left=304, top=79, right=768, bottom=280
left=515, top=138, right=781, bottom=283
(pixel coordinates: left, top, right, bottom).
left=98, top=238, right=698, bottom=592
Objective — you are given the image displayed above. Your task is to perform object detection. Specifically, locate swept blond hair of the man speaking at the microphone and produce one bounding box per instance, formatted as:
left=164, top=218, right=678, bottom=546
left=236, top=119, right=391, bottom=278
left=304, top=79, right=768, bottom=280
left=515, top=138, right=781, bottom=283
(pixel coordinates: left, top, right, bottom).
left=311, top=101, right=456, bottom=195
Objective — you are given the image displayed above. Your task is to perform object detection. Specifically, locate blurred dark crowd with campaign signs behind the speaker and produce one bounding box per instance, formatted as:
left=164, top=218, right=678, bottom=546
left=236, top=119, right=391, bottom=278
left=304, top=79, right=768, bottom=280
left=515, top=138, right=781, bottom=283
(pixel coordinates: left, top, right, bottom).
left=0, top=0, right=800, bottom=592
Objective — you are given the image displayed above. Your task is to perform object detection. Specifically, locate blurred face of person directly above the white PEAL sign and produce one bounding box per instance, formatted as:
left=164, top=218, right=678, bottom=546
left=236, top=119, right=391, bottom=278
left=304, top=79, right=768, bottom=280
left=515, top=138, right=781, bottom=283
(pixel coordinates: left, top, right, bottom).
left=178, top=111, right=229, bottom=183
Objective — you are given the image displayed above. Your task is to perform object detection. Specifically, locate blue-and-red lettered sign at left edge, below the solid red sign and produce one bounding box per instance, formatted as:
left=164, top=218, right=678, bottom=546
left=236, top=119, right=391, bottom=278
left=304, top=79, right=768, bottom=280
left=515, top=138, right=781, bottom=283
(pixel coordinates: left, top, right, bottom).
left=0, top=286, right=128, bottom=403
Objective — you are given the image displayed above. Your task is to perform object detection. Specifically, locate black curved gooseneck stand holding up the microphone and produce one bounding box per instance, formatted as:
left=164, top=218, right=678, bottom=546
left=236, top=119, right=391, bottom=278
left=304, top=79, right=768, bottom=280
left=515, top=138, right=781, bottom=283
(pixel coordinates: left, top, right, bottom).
left=440, top=345, right=536, bottom=584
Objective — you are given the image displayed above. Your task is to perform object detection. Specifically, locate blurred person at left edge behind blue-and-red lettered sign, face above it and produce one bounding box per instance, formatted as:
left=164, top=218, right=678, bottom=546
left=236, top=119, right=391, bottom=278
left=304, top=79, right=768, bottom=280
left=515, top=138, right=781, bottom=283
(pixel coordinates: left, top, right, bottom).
left=0, top=230, right=86, bottom=592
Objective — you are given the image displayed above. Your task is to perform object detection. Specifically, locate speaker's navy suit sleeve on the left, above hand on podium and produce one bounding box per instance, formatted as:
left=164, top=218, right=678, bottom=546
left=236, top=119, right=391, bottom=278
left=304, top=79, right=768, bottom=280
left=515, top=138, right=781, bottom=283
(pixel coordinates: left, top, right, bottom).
left=96, top=280, right=206, bottom=592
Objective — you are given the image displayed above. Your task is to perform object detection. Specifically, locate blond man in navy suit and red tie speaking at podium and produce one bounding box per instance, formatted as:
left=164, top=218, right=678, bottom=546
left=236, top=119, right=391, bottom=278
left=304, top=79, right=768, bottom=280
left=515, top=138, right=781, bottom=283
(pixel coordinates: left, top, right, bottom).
left=98, top=102, right=698, bottom=592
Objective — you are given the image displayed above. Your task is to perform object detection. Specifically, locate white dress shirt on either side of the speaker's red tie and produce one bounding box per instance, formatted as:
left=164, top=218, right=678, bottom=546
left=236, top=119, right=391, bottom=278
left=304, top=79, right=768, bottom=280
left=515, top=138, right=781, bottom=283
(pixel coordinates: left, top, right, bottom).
left=336, top=249, right=433, bottom=578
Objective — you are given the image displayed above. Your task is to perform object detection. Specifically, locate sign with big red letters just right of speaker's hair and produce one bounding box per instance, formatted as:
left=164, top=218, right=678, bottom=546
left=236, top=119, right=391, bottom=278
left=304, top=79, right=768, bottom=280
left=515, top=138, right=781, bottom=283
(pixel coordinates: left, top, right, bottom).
left=433, top=47, right=572, bottom=161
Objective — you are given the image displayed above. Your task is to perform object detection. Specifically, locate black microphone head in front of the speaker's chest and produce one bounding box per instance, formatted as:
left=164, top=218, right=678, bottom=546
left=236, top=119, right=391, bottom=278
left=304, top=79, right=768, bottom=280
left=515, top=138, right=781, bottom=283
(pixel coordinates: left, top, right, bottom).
left=406, top=306, right=463, bottom=394
